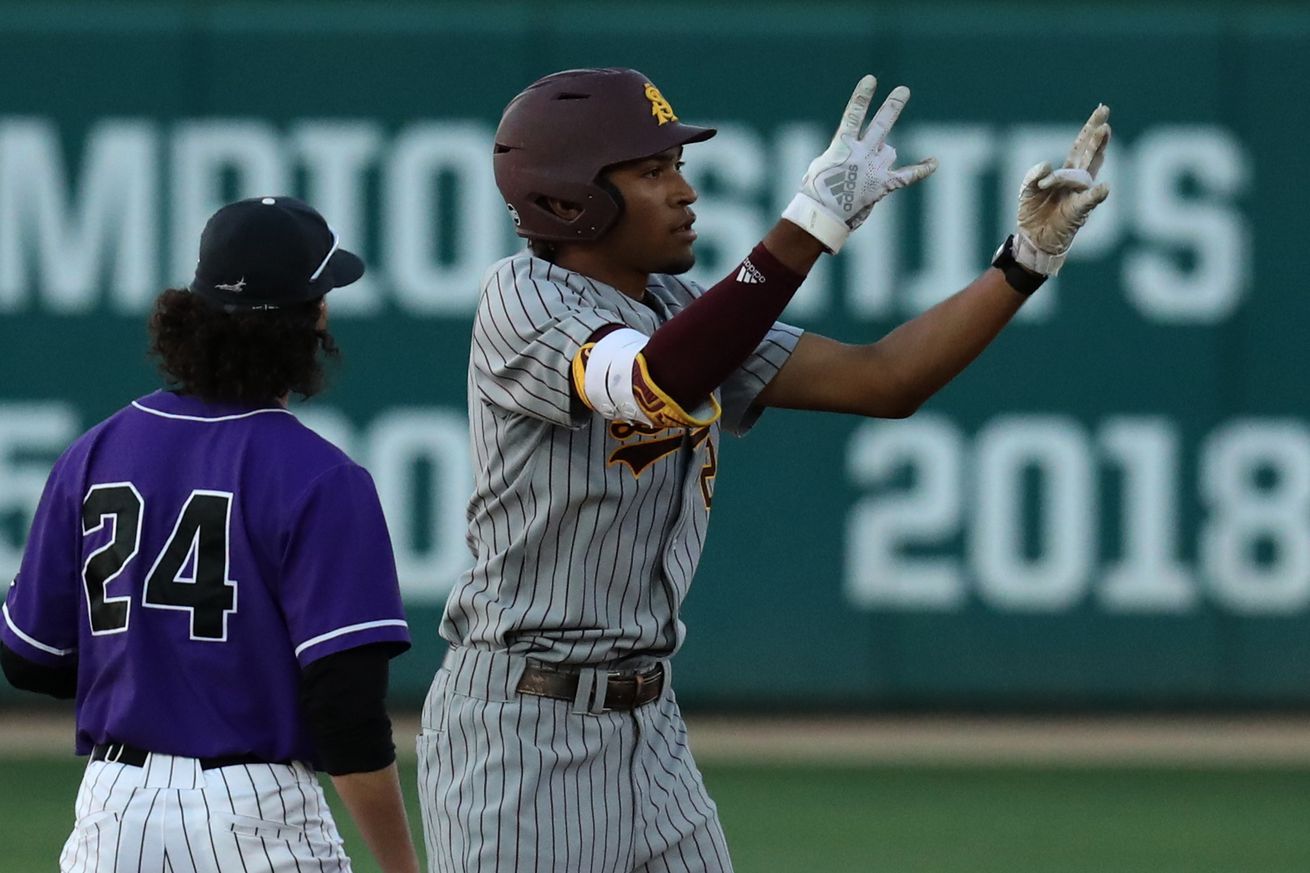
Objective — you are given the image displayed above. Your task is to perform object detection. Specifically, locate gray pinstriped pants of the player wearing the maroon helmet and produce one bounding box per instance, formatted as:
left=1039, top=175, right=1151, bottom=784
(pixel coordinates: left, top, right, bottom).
left=418, top=649, right=732, bottom=873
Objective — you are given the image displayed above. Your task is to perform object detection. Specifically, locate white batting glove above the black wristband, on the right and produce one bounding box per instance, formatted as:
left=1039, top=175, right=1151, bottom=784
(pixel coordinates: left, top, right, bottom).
left=1014, top=104, right=1110, bottom=275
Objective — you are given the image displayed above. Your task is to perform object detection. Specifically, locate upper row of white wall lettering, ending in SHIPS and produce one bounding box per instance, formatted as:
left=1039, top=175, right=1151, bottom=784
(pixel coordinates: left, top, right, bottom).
left=0, top=117, right=1252, bottom=319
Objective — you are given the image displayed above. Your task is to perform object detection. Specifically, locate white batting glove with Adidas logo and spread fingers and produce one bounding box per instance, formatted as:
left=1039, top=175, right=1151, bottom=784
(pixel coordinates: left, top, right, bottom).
left=782, top=76, right=937, bottom=254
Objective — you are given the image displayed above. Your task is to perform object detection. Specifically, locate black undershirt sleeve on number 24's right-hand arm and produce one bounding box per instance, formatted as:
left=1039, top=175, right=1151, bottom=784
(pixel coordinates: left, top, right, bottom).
left=300, top=642, right=405, bottom=776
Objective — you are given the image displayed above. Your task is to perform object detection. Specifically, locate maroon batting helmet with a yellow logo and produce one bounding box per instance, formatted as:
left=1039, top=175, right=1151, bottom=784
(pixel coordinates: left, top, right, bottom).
left=493, top=69, right=715, bottom=243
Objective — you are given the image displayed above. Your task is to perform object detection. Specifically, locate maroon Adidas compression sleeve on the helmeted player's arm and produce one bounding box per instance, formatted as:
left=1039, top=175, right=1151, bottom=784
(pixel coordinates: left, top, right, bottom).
left=642, top=243, right=804, bottom=409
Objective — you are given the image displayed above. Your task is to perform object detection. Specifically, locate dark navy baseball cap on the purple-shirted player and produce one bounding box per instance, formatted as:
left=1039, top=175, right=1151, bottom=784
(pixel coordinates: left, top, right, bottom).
left=190, top=197, right=364, bottom=312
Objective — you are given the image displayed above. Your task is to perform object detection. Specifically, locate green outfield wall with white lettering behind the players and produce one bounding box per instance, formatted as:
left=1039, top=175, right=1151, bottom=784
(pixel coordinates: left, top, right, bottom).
left=0, top=3, right=1310, bottom=708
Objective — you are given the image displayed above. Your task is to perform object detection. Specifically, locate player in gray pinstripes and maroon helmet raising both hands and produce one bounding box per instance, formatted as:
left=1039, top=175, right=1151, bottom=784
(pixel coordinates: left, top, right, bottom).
left=419, top=69, right=1110, bottom=873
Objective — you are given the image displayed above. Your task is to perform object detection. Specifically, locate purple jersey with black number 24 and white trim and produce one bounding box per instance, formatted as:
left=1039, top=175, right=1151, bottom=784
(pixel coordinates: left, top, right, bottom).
left=0, top=392, right=409, bottom=762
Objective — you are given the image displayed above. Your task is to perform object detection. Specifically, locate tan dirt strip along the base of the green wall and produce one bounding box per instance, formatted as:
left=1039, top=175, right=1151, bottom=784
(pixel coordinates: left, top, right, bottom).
left=10, top=710, right=1310, bottom=767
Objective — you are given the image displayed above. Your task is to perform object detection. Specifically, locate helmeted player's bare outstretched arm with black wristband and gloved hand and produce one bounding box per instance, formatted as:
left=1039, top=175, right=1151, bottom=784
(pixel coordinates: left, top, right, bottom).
left=757, top=106, right=1110, bottom=418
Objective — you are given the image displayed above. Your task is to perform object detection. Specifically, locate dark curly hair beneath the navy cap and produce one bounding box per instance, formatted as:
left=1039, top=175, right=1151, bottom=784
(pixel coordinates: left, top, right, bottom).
left=149, top=288, right=341, bottom=404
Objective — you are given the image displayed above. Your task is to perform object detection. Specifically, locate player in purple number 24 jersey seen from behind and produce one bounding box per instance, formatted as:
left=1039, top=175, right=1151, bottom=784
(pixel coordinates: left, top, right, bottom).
left=0, top=197, right=418, bottom=873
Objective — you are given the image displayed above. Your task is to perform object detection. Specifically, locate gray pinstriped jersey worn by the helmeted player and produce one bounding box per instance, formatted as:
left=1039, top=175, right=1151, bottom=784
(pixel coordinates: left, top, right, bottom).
left=441, top=253, right=800, bottom=665
